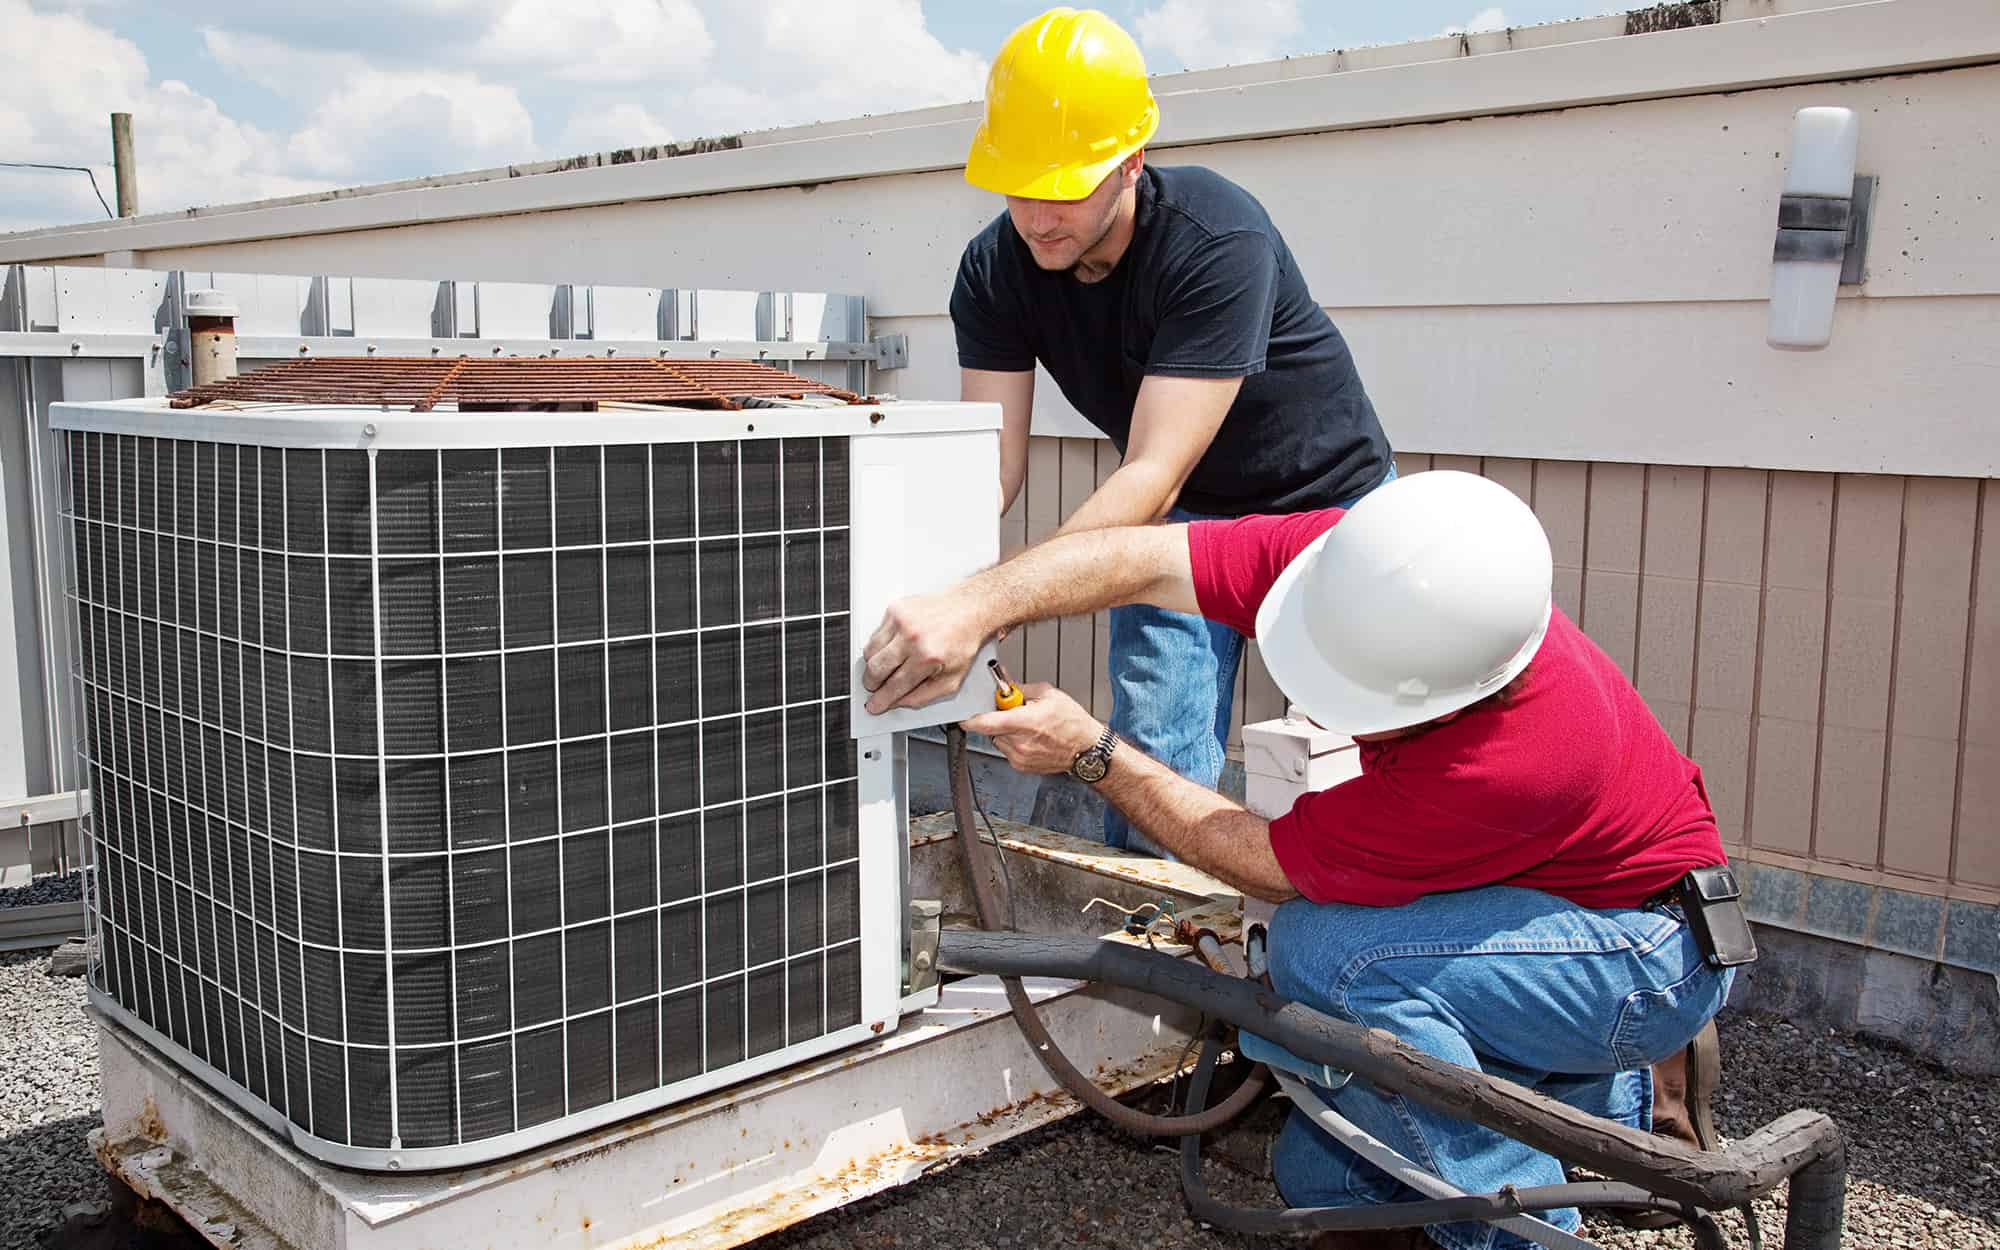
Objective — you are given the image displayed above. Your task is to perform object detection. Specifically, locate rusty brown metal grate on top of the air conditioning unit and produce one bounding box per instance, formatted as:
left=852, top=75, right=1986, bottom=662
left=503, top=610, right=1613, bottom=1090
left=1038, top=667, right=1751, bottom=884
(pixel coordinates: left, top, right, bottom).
left=172, top=356, right=860, bottom=412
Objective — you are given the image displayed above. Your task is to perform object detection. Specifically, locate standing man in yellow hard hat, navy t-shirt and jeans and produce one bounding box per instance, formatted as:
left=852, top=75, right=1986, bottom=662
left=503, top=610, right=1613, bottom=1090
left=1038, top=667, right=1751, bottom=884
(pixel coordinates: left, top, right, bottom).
left=930, top=8, right=1394, bottom=848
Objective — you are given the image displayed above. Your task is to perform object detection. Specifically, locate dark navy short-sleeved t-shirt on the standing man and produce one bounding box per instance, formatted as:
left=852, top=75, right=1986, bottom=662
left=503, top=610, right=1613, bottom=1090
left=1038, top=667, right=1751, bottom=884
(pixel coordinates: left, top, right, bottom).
left=952, top=166, right=1390, bottom=516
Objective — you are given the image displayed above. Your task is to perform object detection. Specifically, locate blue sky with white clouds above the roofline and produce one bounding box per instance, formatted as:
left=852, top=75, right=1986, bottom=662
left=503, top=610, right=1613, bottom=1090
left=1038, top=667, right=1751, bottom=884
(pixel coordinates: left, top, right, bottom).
left=0, top=0, right=1622, bottom=232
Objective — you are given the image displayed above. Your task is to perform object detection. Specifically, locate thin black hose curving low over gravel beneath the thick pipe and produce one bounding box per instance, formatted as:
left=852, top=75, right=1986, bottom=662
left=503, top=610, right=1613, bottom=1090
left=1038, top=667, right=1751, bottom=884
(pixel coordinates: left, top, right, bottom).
left=1180, top=1040, right=1712, bottom=1236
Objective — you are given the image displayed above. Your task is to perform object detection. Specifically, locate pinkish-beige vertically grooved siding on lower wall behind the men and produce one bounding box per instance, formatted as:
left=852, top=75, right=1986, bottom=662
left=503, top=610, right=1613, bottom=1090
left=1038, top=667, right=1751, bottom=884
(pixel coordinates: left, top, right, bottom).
left=1004, top=438, right=2000, bottom=902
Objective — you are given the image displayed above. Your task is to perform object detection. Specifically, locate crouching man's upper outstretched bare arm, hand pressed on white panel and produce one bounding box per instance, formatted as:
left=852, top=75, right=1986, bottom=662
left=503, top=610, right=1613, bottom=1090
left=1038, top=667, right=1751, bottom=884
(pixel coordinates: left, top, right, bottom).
left=862, top=526, right=1196, bottom=712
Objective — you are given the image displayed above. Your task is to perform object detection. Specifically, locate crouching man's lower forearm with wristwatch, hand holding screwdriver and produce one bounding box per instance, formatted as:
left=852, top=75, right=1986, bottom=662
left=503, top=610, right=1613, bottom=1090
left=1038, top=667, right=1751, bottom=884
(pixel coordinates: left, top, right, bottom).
left=966, top=682, right=1298, bottom=902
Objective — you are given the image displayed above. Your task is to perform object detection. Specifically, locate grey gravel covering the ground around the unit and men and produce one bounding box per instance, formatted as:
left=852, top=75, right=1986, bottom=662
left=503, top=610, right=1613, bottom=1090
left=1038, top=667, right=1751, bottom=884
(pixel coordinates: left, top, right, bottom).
left=0, top=952, right=2000, bottom=1250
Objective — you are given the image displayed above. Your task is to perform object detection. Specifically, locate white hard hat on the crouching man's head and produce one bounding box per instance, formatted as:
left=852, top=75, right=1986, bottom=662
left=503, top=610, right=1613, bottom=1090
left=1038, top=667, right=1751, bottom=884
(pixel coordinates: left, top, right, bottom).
left=1256, top=470, right=1552, bottom=734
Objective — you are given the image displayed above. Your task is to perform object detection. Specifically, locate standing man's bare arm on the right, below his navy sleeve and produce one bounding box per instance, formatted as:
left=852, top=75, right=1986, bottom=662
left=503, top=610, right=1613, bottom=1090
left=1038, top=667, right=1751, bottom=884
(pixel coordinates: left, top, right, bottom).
left=1056, top=376, right=1244, bottom=534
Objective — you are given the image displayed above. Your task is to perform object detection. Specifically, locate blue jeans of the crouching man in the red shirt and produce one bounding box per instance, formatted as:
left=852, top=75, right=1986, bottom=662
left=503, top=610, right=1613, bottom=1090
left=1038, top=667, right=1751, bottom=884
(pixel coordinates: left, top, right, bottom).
left=1270, top=886, right=1732, bottom=1250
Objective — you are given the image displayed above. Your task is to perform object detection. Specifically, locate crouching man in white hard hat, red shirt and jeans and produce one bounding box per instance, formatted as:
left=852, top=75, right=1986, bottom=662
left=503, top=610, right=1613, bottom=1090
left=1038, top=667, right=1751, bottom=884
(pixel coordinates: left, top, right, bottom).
left=864, top=472, right=1730, bottom=1250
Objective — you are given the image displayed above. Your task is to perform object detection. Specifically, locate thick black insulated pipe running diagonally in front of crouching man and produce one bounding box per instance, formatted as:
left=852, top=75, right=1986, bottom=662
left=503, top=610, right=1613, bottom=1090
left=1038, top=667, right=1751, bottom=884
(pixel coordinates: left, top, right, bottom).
left=938, top=930, right=1846, bottom=1250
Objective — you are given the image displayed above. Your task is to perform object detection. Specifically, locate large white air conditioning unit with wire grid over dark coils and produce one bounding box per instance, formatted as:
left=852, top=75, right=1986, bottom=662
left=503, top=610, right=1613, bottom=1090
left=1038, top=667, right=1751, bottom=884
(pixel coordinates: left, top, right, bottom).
left=52, top=364, right=998, bottom=1168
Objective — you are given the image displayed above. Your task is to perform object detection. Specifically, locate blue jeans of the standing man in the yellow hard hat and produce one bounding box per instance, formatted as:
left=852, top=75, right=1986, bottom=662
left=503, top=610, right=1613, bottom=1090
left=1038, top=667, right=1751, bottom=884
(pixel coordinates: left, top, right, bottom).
left=1104, top=460, right=1396, bottom=854
